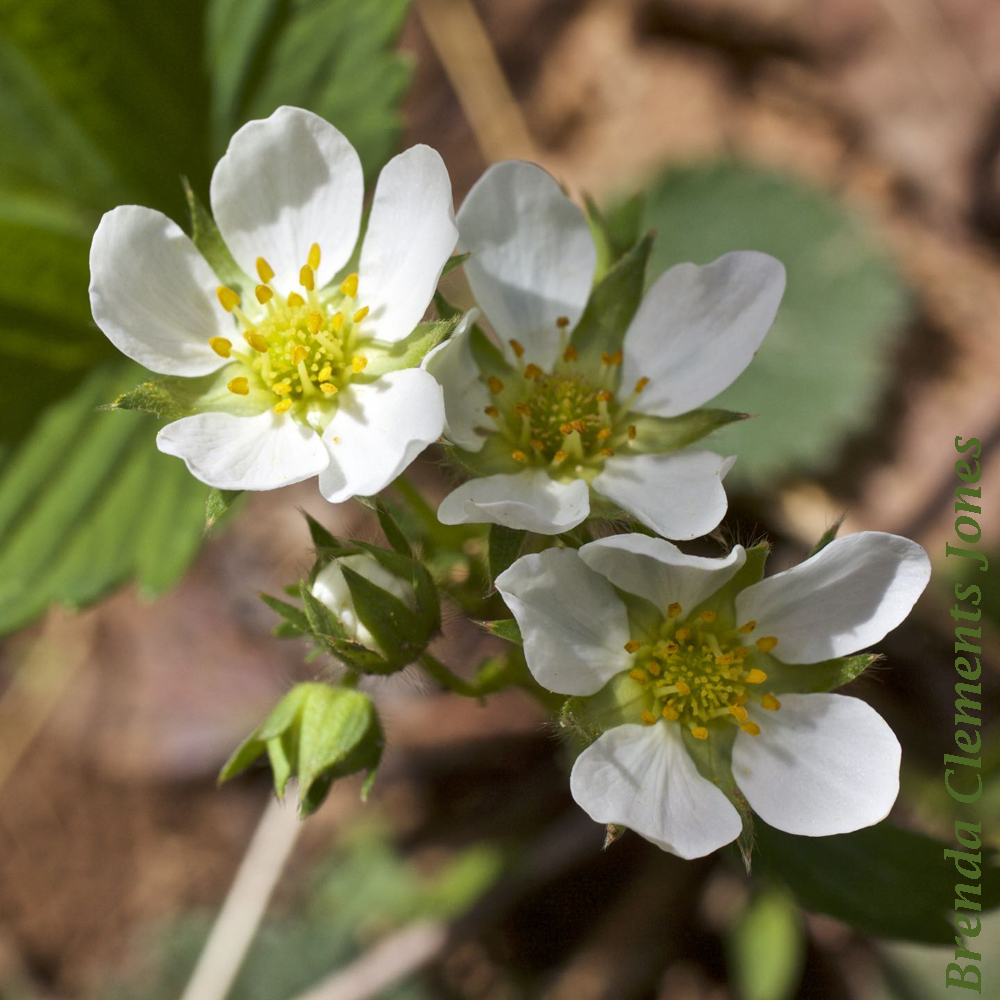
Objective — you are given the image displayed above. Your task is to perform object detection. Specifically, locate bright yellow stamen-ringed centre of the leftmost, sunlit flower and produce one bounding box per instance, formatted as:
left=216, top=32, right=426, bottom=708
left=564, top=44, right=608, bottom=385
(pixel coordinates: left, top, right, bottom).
left=209, top=243, right=371, bottom=428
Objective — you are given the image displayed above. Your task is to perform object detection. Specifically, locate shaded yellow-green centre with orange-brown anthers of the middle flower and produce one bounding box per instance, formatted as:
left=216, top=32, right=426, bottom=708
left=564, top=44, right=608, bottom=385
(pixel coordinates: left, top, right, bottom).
left=485, top=332, right=649, bottom=480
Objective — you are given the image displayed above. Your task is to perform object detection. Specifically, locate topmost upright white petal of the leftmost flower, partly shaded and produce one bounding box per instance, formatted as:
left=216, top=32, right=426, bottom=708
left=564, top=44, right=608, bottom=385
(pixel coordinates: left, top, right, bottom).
left=211, top=107, right=365, bottom=294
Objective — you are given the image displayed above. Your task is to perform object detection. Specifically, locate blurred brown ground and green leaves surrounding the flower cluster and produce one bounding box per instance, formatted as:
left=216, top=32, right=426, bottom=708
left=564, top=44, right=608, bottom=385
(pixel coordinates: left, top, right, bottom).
left=0, top=0, right=1000, bottom=1000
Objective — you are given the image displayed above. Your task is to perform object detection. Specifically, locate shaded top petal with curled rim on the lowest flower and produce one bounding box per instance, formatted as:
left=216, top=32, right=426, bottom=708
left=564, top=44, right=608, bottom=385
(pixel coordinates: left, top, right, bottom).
left=579, top=534, right=747, bottom=614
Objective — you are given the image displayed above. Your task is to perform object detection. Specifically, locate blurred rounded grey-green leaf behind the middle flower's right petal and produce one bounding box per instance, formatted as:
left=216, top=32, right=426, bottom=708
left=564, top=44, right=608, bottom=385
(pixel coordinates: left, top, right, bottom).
left=645, top=162, right=910, bottom=489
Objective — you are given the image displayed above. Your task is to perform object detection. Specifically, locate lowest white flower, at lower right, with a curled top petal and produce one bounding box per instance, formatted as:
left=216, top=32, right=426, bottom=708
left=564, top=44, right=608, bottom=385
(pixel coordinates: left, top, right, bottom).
left=497, top=532, right=930, bottom=858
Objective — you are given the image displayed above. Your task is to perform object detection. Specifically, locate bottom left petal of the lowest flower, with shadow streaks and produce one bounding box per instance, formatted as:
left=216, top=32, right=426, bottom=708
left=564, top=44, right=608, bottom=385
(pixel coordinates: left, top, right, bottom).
left=569, top=722, right=743, bottom=858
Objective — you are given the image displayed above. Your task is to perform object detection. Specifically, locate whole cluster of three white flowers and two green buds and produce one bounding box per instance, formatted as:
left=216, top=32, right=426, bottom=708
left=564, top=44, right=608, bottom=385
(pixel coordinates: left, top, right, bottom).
left=90, top=108, right=929, bottom=858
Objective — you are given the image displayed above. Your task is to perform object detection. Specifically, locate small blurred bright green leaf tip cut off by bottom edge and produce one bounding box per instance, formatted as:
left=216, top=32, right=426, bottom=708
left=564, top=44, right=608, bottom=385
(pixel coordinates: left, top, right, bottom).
left=728, top=889, right=806, bottom=1000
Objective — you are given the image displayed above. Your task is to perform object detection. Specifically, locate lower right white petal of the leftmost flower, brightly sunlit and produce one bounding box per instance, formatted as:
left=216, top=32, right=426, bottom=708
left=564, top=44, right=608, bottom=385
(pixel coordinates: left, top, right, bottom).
left=319, top=368, right=444, bottom=503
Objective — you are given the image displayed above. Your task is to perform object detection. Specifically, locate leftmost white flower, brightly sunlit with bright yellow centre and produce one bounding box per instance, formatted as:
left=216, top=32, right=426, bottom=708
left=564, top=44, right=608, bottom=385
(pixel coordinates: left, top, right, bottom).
left=90, top=107, right=458, bottom=502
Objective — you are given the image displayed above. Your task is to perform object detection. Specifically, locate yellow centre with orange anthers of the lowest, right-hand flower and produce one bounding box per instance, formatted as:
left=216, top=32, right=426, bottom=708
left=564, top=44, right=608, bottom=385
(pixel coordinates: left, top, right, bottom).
left=625, top=604, right=781, bottom=740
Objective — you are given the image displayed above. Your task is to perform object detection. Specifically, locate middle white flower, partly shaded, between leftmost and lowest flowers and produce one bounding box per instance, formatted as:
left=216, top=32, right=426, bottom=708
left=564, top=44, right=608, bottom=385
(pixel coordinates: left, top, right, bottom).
left=427, top=161, right=785, bottom=538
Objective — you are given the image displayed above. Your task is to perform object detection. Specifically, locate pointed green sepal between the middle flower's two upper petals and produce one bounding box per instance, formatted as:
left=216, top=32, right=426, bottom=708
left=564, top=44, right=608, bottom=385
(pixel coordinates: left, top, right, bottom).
left=570, top=236, right=653, bottom=380
